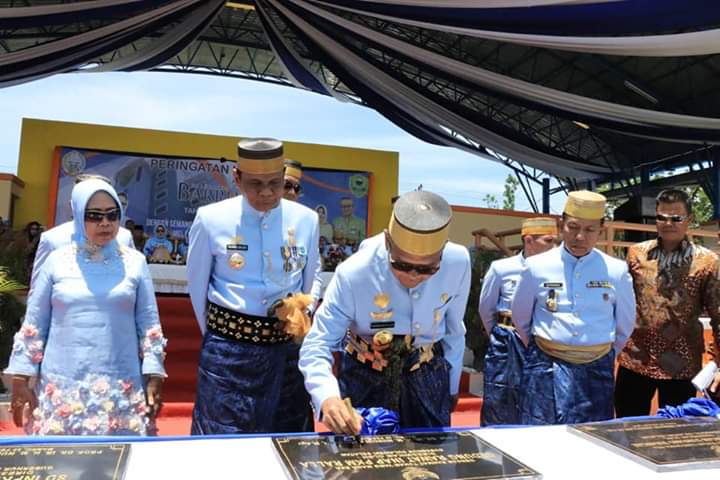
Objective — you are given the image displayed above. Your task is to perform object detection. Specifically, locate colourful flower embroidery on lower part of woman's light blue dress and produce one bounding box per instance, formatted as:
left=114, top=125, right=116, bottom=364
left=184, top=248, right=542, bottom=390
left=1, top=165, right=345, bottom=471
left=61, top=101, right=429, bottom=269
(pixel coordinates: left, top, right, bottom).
left=26, top=375, right=149, bottom=435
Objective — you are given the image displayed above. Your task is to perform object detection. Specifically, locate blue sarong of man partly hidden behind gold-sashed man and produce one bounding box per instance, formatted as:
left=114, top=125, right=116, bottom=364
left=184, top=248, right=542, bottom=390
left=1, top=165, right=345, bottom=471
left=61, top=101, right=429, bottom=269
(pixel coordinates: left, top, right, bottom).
left=480, top=325, right=525, bottom=426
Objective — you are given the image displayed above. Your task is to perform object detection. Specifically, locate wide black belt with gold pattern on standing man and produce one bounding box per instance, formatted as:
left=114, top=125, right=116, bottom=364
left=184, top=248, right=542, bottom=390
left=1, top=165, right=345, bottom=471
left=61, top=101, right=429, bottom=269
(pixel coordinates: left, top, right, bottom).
left=207, top=302, right=292, bottom=345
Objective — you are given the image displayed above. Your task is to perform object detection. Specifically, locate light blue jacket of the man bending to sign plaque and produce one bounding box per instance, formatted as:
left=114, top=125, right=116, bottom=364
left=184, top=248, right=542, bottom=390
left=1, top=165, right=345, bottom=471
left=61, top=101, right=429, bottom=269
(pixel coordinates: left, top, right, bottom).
left=299, top=234, right=471, bottom=412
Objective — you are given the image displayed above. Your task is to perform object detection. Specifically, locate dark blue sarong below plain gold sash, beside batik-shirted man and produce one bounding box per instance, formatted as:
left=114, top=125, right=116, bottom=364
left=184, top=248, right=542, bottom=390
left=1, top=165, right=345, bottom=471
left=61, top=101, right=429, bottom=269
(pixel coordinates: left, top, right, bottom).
left=520, top=340, right=615, bottom=425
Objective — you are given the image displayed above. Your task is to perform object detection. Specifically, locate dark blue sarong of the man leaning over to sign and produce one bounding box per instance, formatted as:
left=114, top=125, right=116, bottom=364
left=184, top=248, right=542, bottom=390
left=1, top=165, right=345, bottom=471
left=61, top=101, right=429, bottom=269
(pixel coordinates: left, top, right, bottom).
left=338, top=343, right=451, bottom=429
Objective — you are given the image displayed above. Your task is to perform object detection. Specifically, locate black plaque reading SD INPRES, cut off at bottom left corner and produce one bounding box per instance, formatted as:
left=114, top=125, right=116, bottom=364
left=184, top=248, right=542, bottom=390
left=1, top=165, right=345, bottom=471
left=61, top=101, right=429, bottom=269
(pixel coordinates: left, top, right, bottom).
left=0, top=443, right=130, bottom=480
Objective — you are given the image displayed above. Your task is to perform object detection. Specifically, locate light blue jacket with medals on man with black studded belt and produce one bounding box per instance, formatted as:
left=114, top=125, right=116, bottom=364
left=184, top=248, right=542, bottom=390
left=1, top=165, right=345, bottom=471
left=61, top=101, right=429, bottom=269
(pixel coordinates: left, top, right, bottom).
left=187, top=196, right=321, bottom=334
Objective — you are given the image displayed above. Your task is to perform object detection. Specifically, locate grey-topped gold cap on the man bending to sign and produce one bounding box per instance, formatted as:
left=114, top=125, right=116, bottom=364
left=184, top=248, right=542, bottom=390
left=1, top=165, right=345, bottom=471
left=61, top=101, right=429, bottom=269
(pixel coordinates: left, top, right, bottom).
left=388, top=191, right=452, bottom=256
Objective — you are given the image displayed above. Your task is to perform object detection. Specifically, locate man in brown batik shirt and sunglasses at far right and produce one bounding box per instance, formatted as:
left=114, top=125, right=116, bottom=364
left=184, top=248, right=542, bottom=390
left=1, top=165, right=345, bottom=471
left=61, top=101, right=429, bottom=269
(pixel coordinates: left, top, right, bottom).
left=615, top=190, right=720, bottom=417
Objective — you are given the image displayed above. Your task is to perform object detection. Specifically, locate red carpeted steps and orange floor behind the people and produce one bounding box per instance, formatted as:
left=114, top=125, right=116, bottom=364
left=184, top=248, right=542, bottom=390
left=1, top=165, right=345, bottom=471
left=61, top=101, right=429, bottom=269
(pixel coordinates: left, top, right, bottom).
left=0, top=295, right=482, bottom=435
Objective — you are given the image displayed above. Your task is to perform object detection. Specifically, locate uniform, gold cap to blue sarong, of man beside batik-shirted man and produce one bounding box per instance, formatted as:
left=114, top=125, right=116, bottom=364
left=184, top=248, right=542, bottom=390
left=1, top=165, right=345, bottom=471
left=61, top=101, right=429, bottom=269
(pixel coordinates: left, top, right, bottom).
left=512, top=192, right=635, bottom=424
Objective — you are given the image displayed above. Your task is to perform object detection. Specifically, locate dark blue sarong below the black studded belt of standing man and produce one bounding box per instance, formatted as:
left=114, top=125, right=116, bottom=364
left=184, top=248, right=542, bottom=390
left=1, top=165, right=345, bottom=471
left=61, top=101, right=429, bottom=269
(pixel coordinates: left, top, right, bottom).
left=191, top=332, right=312, bottom=435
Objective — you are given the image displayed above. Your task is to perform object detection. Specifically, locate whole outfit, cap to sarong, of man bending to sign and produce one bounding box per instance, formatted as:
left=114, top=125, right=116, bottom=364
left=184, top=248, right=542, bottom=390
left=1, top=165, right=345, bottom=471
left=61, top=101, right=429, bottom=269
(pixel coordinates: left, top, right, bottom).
left=300, top=192, right=471, bottom=428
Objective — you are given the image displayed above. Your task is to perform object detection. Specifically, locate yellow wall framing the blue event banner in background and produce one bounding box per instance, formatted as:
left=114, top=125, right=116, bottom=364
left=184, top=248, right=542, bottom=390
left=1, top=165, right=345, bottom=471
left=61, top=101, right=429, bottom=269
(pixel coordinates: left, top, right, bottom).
left=14, top=118, right=398, bottom=233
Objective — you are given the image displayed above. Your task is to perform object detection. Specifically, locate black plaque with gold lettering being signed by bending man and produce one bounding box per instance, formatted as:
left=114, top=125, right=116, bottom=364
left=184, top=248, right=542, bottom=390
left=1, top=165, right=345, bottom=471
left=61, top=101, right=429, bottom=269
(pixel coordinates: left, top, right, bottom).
left=273, top=432, right=542, bottom=480
